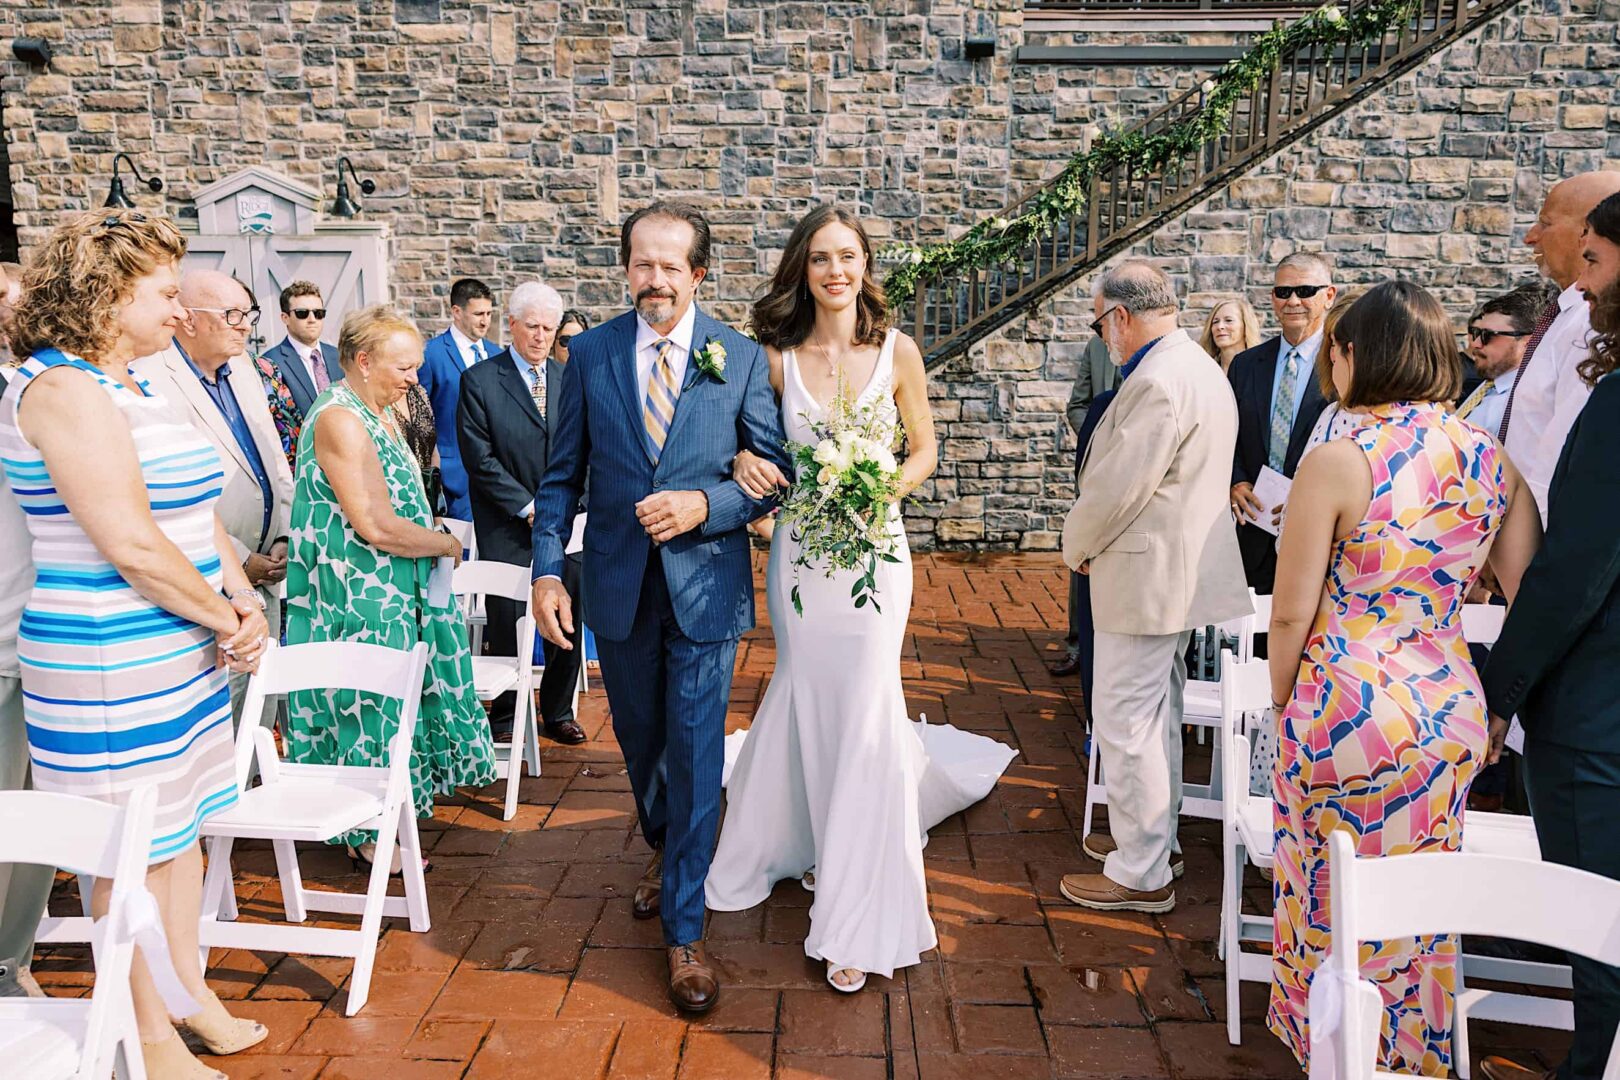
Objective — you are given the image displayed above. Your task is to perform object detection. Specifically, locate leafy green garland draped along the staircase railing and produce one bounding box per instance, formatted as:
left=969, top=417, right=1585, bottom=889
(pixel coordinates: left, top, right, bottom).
left=883, top=0, right=1416, bottom=309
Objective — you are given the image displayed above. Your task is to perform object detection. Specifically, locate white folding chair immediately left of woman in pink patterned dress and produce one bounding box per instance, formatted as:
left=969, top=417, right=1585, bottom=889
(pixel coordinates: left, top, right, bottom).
left=1218, top=651, right=1275, bottom=1046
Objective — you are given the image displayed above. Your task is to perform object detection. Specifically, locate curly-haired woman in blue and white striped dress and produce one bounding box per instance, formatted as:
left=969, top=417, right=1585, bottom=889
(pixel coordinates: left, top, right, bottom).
left=0, top=210, right=267, bottom=1080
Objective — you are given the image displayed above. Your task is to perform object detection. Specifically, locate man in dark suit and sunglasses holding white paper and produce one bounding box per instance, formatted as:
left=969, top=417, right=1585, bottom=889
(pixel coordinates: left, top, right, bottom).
left=1226, top=251, right=1338, bottom=596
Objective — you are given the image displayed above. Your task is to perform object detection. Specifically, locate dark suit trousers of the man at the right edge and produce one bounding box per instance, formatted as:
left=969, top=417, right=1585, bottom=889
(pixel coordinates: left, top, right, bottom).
left=1524, top=735, right=1620, bottom=1080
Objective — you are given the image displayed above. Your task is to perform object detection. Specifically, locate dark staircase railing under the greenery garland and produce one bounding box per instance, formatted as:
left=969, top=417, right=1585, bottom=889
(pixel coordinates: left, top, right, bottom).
left=909, top=0, right=1520, bottom=366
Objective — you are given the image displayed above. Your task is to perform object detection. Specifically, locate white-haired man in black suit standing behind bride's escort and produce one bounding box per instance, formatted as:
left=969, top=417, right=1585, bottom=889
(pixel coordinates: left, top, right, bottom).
left=455, top=282, right=585, bottom=745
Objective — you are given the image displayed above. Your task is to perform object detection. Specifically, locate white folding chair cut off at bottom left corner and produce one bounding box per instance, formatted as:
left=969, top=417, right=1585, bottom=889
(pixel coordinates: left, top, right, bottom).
left=0, top=787, right=178, bottom=1080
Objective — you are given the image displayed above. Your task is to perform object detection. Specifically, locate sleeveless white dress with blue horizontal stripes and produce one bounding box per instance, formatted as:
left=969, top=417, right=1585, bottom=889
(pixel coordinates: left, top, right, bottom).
left=0, top=348, right=237, bottom=863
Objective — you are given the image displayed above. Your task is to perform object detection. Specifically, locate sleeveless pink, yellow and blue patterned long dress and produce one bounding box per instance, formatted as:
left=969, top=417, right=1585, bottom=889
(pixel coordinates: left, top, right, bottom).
left=1267, top=403, right=1507, bottom=1077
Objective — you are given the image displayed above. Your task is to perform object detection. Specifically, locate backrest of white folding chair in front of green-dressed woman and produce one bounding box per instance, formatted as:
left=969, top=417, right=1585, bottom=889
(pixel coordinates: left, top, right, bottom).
left=237, top=641, right=428, bottom=790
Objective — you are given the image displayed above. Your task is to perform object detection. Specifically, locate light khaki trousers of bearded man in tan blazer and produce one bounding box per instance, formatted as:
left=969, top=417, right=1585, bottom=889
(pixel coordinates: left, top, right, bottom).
left=1090, top=630, right=1192, bottom=891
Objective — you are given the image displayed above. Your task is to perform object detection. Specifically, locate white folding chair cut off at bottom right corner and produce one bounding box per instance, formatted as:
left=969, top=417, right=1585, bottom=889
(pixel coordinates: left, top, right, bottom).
left=1311, top=832, right=1620, bottom=1080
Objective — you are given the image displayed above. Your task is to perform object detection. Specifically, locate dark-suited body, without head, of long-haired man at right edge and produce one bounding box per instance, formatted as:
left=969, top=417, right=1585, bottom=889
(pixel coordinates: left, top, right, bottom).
left=1479, top=354, right=1620, bottom=1080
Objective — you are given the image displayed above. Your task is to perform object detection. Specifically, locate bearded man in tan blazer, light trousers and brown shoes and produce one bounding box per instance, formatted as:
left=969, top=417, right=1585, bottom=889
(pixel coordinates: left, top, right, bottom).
left=1061, top=262, right=1252, bottom=912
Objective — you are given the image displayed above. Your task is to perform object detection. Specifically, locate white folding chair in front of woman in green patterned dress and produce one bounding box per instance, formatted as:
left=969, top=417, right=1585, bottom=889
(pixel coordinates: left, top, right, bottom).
left=201, top=641, right=433, bottom=1015
